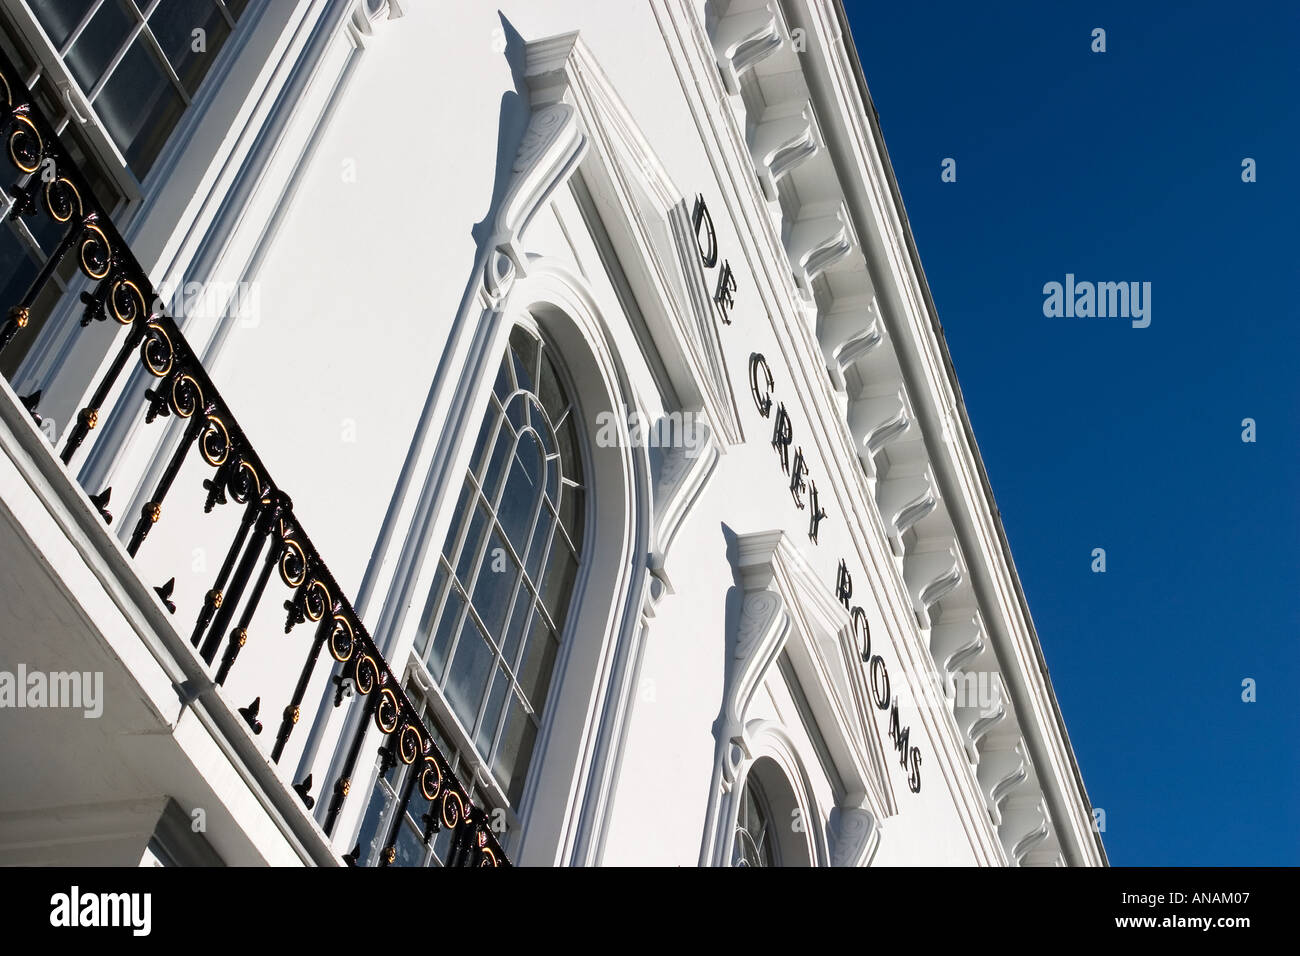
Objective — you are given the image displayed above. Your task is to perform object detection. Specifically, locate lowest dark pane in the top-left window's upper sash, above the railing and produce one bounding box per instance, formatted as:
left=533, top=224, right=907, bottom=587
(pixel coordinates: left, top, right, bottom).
left=95, top=39, right=185, bottom=178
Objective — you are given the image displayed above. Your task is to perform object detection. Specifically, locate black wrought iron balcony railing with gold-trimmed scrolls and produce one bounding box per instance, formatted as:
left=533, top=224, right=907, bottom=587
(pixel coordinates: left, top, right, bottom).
left=0, top=53, right=508, bottom=866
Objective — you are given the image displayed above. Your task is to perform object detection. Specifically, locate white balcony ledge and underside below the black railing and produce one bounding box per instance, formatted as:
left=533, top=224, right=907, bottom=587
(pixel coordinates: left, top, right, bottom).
left=0, top=382, right=342, bottom=866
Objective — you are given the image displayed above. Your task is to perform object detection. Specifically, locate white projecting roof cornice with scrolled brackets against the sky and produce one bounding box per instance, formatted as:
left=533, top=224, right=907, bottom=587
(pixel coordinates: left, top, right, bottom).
left=657, top=0, right=1105, bottom=865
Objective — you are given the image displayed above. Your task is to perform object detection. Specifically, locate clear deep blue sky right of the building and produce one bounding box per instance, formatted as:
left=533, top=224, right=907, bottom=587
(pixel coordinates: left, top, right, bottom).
left=846, top=0, right=1300, bottom=866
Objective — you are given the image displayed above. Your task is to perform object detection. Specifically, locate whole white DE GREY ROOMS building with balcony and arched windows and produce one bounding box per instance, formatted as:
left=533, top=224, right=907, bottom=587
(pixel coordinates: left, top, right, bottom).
left=0, top=0, right=1105, bottom=866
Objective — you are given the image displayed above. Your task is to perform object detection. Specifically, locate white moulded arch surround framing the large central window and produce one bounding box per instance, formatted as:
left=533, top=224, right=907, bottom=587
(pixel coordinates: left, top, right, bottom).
left=377, top=264, right=653, bottom=865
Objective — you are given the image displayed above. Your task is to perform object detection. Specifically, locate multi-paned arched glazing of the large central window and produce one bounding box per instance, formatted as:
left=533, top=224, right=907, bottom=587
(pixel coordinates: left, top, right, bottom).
left=416, top=325, right=584, bottom=804
